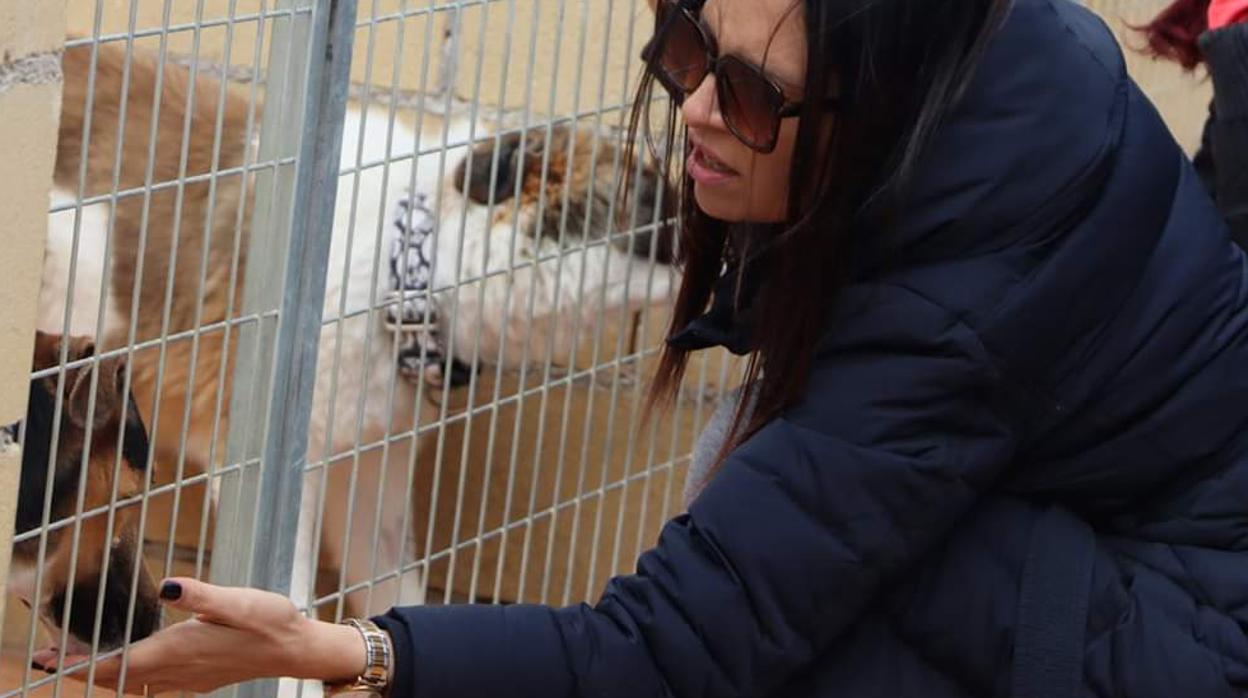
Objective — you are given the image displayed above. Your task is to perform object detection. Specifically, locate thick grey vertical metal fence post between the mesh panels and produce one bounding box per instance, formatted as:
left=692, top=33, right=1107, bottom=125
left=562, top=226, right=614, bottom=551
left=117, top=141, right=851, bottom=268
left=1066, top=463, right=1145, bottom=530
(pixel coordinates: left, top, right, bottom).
left=211, top=0, right=357, bottom=697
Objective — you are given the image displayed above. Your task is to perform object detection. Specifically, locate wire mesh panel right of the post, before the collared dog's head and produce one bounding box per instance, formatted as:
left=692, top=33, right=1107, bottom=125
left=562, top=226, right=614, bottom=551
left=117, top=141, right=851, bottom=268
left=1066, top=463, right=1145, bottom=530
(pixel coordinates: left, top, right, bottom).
left=296, top=0, right=693, bottom=629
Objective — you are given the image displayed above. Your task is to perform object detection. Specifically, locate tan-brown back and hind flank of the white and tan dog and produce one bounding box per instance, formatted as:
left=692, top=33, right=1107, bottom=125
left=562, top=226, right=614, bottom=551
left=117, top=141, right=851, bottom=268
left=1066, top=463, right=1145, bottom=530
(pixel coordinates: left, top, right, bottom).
left=56, top=41, right=261, bottom=474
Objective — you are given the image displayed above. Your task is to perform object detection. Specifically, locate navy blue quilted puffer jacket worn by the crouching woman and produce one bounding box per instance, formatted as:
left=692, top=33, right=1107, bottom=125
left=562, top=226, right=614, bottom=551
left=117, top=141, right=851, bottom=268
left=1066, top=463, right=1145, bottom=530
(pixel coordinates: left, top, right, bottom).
left=381, top=0, right=1248, bottom=698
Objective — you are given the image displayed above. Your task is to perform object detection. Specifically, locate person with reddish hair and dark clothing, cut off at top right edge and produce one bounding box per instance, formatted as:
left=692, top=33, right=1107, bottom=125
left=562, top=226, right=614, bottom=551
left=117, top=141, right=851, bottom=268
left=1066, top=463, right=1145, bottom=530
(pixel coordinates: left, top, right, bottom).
left=1144, top=0, right=1248, bottom=247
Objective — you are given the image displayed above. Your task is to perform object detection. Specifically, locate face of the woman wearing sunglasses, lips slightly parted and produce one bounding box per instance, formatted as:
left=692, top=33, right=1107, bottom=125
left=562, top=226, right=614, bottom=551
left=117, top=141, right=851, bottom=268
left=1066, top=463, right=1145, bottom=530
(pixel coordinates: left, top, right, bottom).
left=681, top=0, right=806, bottom=222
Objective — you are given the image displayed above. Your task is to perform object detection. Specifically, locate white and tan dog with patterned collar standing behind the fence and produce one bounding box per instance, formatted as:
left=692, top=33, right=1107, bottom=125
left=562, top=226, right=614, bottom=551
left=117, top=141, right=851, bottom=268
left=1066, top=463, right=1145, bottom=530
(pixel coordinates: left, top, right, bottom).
left=41, top=36, right=673, bottom=634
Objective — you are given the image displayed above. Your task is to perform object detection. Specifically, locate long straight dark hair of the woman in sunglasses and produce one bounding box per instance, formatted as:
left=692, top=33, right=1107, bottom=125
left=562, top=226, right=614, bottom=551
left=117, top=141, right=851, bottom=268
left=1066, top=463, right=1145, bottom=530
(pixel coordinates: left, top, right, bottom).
left=630, top=0, right=1010, bottom=469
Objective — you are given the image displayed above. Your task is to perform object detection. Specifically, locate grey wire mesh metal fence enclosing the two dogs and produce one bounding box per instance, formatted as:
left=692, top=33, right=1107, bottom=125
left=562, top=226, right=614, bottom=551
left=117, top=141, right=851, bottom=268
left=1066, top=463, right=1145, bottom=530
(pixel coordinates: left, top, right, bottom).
left=0, top=0, right=1204, bottom=698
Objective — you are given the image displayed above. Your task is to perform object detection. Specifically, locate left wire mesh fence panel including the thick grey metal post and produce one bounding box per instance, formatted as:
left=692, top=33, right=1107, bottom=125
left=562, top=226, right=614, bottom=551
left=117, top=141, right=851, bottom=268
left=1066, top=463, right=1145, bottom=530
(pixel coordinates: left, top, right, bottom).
left=0, top=0, right=354, bottom=696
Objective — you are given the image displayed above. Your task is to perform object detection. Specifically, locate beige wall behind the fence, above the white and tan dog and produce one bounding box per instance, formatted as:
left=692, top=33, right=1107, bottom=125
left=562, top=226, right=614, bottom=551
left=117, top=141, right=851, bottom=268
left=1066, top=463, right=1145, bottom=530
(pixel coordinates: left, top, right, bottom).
left=67, top=0, right=650, bottom=119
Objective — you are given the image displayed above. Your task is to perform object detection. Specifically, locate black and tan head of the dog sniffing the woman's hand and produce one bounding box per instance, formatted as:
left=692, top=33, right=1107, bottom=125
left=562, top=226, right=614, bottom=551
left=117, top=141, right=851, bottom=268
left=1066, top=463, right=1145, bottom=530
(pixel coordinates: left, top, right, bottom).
left=0, top=333, right=160, bottom=653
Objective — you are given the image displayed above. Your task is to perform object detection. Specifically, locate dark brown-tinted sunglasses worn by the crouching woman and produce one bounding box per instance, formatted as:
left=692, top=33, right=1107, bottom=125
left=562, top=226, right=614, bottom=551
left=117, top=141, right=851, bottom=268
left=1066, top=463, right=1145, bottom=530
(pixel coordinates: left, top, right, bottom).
left=641, top=0, right=836, bottom=154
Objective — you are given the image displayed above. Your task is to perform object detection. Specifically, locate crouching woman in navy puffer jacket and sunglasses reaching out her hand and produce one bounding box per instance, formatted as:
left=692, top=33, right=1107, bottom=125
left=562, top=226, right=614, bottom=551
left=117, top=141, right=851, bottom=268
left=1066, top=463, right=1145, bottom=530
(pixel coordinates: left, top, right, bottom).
left=39, top=0, right=1248, bottom=698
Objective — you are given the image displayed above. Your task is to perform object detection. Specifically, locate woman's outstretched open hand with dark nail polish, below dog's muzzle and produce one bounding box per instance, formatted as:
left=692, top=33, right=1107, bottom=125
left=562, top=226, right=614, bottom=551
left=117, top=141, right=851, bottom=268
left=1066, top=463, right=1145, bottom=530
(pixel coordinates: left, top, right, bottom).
left=32, top=579, right=367, bottom=696
